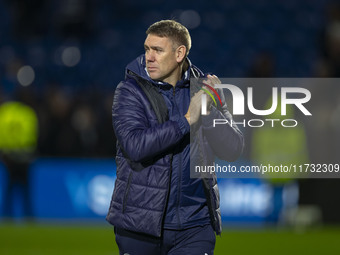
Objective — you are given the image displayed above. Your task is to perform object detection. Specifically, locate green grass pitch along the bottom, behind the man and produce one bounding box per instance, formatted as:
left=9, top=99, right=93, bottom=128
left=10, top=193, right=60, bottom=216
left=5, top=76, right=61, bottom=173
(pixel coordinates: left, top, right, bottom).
left=0, top=223, right=340, bottom=255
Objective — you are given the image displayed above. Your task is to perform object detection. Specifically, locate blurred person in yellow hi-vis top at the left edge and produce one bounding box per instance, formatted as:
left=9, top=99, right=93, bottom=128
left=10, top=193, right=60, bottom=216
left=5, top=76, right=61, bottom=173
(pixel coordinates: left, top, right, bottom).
left=0, top=93, right=38, bottom=219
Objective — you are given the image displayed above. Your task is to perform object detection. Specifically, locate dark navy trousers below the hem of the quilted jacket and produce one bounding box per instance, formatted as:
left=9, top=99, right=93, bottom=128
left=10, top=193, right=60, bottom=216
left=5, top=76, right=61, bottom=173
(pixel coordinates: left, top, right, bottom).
left=115, top=225, right=216, bottom=255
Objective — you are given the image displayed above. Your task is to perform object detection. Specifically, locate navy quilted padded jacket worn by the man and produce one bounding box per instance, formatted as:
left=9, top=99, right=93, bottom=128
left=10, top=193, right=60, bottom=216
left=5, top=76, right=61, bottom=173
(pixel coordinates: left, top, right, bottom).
left=107, top=55, right=243, bottom=236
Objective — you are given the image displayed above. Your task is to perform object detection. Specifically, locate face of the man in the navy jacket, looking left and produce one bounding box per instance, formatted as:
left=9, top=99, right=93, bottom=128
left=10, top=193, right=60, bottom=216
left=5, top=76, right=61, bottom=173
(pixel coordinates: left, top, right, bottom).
left=144, top=34, right=179, bottom=82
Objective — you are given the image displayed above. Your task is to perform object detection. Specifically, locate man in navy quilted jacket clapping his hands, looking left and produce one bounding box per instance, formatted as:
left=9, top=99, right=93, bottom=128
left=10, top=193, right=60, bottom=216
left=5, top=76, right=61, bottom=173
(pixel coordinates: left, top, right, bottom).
left=107, top=20, right=243, bottom=255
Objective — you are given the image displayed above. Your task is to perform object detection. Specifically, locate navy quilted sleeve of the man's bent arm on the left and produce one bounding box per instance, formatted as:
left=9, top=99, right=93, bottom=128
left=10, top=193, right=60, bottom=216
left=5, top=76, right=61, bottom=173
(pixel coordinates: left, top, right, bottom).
left=112, top=82, right=189, bottom=162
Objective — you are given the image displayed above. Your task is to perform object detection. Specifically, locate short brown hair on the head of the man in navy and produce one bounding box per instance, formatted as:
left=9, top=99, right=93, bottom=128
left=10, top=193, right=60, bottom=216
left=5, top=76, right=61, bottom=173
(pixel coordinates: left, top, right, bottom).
left=146, top=20, right=191, bottom=56
